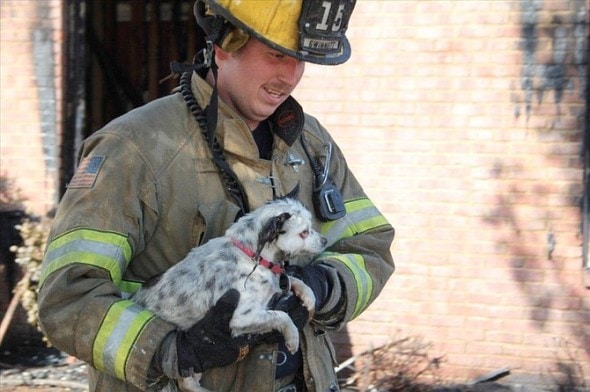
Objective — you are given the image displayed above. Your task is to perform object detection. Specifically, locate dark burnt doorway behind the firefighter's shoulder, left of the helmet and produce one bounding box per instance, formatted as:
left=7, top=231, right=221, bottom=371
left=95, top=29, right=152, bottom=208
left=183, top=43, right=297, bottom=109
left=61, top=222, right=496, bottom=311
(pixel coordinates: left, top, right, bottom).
left=60, top=0, right=196, bottom=196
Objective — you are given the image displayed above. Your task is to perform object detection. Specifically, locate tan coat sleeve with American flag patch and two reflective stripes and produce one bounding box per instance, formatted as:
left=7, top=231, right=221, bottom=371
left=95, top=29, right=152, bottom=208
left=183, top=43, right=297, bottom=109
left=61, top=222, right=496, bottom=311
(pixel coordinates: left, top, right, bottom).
left=39, top=132, right=173, bottom=389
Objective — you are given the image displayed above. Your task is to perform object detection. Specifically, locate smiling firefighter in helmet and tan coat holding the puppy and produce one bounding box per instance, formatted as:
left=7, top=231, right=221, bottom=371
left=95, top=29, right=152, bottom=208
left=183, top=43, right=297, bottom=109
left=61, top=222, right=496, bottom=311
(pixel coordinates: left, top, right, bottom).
left=39, top=0, right=394, bottom=392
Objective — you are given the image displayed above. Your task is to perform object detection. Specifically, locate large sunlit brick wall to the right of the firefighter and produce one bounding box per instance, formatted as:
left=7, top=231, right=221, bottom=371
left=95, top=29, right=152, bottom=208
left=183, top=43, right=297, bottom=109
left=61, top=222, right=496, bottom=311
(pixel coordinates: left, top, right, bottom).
left=295, top=0, right=590, bottom=386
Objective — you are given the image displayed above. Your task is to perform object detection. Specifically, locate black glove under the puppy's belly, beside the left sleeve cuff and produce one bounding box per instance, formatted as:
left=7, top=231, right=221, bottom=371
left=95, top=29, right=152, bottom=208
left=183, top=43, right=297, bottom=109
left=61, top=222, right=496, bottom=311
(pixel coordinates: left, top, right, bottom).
left=176, top=289, right=250, bottom=377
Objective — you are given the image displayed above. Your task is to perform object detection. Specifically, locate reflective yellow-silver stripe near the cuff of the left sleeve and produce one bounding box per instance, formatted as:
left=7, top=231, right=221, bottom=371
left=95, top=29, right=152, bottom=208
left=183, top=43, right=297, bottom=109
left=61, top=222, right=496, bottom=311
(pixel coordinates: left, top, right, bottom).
left=92, top=300, right=154, bottom=380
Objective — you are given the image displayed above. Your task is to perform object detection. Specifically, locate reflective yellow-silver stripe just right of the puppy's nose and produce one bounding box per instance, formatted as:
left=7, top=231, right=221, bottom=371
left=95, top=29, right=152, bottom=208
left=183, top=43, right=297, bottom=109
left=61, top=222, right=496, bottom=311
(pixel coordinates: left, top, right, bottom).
left=320, top=198, right=389, bottom=244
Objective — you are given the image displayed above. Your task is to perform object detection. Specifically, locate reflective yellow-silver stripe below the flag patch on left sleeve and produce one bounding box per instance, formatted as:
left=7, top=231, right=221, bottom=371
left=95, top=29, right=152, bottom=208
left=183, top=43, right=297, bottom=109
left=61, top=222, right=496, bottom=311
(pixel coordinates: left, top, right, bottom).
left=41, top=229, right=131, bottom=283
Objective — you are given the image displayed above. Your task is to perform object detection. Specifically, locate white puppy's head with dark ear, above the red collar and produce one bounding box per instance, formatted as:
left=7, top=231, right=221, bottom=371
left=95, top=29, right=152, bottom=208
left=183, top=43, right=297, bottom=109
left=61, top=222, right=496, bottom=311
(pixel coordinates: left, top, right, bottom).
left=257, top=199, right=327, bottom=259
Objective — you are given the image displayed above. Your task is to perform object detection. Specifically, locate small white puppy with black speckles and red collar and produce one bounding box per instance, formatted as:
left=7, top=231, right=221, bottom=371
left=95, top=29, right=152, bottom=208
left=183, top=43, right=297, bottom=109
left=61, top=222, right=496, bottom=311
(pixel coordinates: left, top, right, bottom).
left=132, top=198, right=327, bottom=390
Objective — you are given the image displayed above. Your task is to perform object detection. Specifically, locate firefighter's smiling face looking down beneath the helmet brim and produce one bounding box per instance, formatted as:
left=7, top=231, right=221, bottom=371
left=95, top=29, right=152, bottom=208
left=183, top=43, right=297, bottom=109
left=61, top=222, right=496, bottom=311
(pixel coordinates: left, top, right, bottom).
left=215, top=38, right=305, bottom=129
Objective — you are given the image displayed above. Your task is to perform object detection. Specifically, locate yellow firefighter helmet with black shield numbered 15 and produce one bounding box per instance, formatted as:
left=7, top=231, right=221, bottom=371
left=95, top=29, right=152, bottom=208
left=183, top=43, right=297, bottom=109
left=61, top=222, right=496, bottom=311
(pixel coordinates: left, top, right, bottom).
left=194, top=0, right=356, bottom=65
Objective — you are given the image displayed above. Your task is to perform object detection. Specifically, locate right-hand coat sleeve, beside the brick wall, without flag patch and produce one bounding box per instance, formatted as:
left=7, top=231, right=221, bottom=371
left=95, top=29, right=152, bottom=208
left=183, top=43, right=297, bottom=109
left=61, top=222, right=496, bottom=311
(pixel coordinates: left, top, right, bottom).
left=302, top=125, right=395, bottom=329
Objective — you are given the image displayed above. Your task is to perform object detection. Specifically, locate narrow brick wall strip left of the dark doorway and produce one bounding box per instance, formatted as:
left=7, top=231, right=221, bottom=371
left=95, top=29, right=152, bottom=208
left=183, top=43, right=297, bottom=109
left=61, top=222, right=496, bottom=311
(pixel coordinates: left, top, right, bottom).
left=0, top=0, right=63, bottom=214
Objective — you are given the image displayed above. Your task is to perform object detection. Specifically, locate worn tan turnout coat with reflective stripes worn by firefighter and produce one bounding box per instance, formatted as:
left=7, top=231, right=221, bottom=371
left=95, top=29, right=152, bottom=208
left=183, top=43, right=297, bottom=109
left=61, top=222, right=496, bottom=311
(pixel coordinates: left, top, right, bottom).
left=39, top=74, right=394, bottom=392
